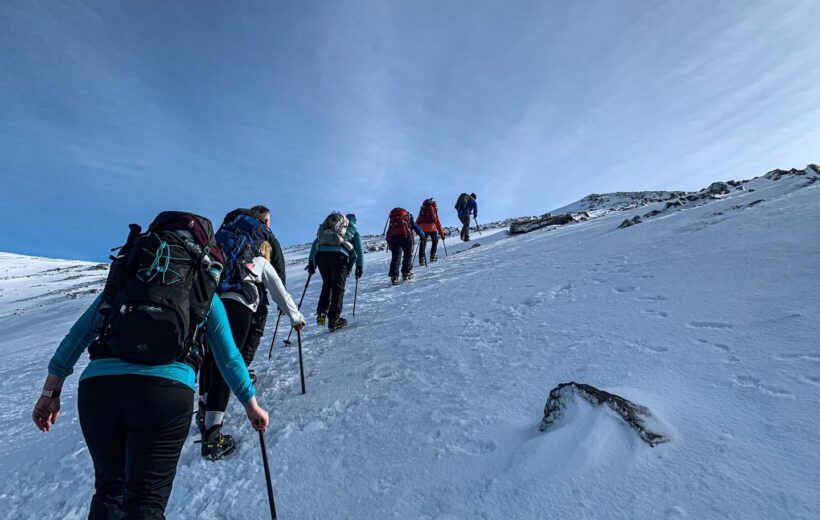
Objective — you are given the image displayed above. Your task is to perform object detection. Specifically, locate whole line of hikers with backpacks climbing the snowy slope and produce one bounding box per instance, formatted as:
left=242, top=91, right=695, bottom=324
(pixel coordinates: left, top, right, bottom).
left=32, top=193, right=478, bottom=519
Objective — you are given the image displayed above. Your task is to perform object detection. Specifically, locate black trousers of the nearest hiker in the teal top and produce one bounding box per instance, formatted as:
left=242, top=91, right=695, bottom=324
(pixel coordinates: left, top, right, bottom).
left=77, top=375, right=194, bottom=520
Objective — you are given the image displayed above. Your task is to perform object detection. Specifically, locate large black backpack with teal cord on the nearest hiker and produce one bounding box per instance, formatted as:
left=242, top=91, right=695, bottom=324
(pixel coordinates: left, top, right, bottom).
left=89, top=211, right=223, bottom=365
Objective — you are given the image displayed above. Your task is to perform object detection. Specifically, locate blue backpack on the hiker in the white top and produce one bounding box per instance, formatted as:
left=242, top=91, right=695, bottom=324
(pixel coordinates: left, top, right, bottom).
left=216, top=209, right=272, bottom=294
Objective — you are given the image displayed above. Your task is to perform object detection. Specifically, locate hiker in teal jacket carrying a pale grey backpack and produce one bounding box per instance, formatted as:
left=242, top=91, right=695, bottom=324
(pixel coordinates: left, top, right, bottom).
left=306, top=211, right=364, bottom=332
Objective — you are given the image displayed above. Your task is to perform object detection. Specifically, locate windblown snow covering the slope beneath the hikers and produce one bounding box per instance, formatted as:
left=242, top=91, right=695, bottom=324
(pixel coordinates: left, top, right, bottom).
left=0, top=171, right=820, bottom=520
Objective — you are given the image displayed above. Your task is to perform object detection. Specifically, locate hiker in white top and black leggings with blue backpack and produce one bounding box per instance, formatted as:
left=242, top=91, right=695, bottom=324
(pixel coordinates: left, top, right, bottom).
left=197, top=209, right=305, bottom=461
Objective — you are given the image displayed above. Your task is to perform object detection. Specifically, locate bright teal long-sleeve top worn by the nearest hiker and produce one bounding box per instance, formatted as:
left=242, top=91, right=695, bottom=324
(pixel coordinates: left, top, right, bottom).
left=48, top=296, right=256, bottom=404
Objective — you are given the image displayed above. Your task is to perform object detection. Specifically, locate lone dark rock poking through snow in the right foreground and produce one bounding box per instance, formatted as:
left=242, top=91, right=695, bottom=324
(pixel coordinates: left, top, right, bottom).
left=539, top=381, right=670, bottom=447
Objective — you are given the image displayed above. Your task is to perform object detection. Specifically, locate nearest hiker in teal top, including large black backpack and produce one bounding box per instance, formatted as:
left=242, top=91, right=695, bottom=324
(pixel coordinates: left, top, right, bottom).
left=32, top=212, right=268, bottom=518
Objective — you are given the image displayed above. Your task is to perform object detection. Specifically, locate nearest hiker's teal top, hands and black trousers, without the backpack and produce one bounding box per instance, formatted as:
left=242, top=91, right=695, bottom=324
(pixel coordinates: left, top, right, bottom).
left=32, top=290, right=268, bottom=518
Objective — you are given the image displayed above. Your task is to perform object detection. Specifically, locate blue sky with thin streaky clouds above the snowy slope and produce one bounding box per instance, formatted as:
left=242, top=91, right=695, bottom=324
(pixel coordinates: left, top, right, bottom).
left=0, top=0, right=820, bottom=260
